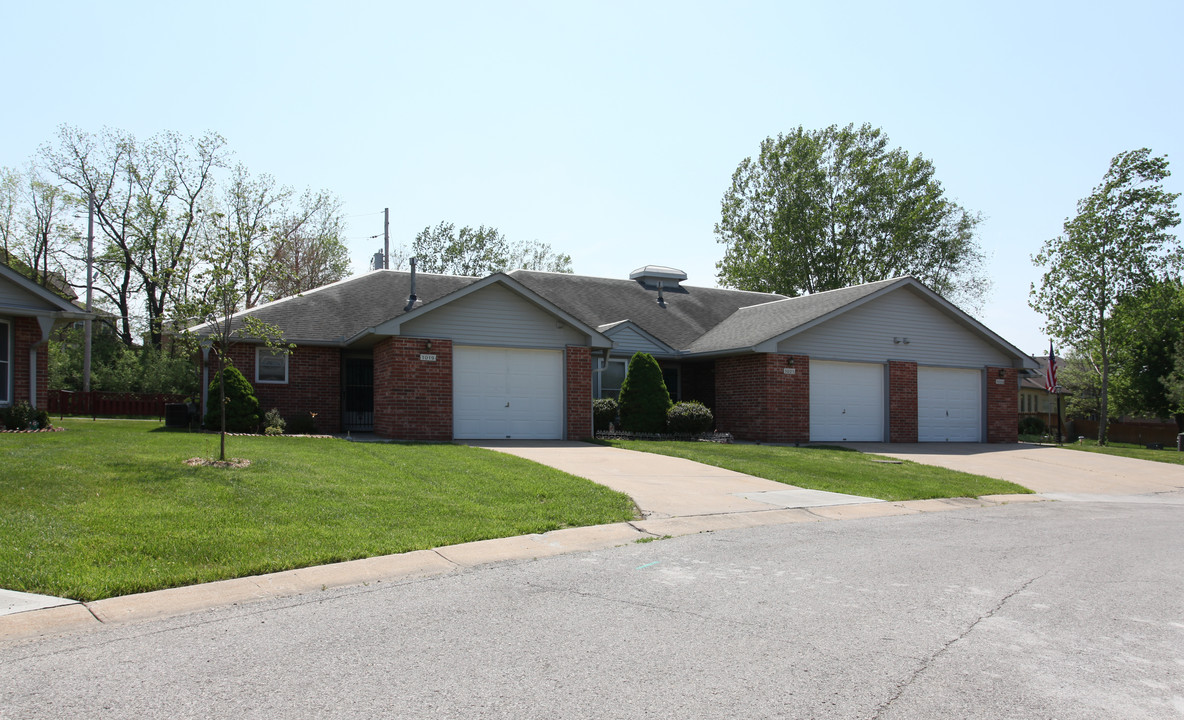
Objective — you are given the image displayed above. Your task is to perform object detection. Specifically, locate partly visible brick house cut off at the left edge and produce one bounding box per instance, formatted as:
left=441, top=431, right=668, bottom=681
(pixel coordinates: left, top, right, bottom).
left=0, top=264, right=90, bottom=407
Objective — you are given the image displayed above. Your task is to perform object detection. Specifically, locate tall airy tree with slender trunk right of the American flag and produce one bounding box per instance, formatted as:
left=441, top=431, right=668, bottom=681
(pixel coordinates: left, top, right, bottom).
left=1028, top=148, right=1182, bottom=444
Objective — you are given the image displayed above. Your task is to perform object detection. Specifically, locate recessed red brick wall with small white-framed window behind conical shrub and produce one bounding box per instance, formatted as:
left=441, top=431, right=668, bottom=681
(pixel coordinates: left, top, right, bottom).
left=210, top=342, right=341, bottom=432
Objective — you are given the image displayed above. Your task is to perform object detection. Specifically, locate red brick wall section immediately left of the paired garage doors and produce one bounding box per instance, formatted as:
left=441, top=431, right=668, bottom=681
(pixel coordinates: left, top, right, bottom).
left=715, top=353, right=810, bottom=443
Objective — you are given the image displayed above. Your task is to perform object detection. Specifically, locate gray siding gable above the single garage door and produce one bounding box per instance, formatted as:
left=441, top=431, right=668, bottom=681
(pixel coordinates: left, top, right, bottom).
left=399, top=284, right=588, bottom=348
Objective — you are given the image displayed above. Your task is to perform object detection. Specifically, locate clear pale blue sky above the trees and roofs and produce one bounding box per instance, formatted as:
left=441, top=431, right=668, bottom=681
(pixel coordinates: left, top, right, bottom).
left=0, top=0, right=1184, bottom=353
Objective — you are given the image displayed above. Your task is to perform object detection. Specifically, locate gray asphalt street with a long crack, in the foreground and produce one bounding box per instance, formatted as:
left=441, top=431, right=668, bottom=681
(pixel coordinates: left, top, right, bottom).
left=0, top=502, right=1184, bottom=720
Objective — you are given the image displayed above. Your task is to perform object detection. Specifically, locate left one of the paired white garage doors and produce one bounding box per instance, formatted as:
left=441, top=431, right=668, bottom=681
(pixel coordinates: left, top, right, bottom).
left=810, top=361, right=884, bottom=442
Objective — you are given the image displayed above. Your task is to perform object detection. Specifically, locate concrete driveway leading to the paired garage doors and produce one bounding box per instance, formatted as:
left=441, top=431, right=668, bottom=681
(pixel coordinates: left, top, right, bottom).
left=841, top=443, right=1184, bottom=504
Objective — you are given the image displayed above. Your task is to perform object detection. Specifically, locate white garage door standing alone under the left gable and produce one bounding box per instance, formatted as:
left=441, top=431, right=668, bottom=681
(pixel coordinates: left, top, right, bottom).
left=452, top=346, right=564, bottom=439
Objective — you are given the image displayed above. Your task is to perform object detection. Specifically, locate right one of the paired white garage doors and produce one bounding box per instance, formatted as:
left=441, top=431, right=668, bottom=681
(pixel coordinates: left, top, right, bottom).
left=916, top=367, right=983, bottom=443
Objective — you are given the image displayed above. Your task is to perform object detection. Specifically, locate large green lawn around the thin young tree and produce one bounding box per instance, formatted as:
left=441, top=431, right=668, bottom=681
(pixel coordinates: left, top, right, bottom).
left=0, top=419, right=633, bottom=600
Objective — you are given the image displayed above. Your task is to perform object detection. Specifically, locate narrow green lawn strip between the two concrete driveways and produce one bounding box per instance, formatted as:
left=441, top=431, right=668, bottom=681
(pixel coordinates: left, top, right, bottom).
left=609, top=441, right=1031, bottom=501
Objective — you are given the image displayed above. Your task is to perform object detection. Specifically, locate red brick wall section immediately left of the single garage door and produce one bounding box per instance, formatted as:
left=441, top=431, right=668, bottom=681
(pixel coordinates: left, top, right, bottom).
left=374, top=336, right=452, bottom=441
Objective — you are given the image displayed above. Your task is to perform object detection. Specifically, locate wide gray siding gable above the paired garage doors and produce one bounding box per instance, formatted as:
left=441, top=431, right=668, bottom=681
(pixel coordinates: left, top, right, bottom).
left=777, top=288, right=1011, bottom=367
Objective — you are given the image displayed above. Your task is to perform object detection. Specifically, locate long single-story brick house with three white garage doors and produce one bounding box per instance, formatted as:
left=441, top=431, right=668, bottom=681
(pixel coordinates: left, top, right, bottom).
left=194, top=265, right=1036, bottom=443
